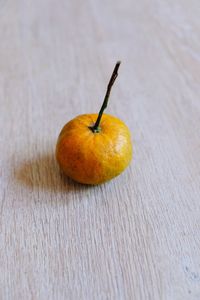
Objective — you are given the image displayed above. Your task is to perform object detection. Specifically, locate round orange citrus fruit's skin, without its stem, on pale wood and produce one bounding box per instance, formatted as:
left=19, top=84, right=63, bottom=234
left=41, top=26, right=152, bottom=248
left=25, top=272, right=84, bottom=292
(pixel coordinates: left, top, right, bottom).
left=56, top=114, right=132, bottom=184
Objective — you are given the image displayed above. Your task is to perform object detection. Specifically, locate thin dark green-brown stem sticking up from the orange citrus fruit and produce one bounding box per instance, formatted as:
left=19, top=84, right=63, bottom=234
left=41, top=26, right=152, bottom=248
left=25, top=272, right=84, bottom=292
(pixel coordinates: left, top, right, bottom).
left=89, top=61, right=121, bottom=133
